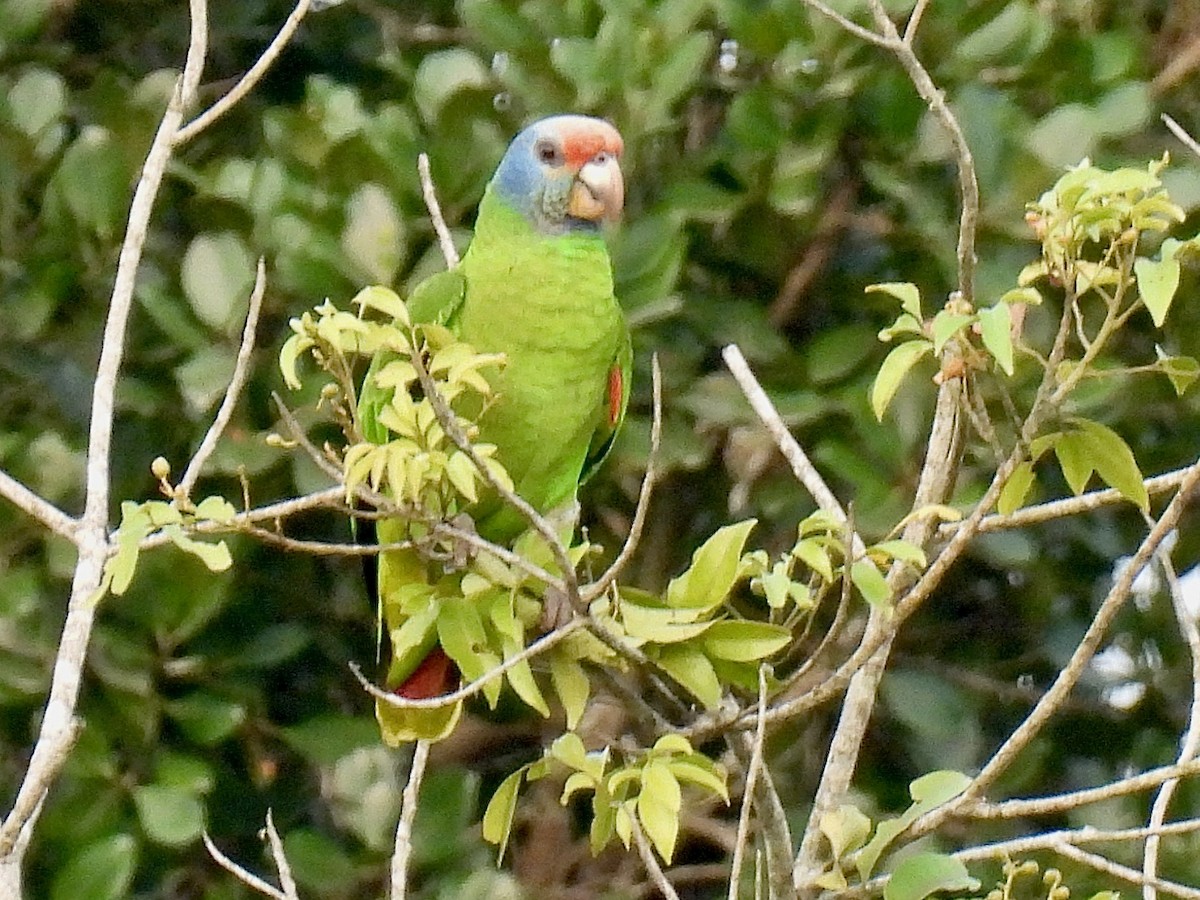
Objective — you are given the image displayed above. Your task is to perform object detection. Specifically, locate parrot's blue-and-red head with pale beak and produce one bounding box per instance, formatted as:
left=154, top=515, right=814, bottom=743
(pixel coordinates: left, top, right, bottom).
left=492, top=115, right=625, bottom=235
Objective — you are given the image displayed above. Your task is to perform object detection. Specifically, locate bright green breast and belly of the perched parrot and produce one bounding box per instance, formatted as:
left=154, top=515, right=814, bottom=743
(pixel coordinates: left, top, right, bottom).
left=455, top=192, right=624, bottom=530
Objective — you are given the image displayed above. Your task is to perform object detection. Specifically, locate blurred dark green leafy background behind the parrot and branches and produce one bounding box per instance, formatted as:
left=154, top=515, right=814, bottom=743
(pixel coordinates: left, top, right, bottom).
left=0, top=0, right=1200, bottom=900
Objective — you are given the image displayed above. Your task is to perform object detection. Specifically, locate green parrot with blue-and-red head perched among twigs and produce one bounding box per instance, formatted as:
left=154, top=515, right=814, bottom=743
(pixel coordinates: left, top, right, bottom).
left=359, top=115, right=631, bottom=745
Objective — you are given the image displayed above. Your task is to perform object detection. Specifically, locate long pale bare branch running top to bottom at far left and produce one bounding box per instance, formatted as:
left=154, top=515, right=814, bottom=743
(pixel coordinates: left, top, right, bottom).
left=0, top=0, right=209, bottom=868
